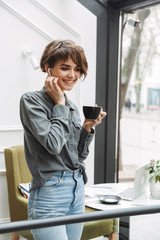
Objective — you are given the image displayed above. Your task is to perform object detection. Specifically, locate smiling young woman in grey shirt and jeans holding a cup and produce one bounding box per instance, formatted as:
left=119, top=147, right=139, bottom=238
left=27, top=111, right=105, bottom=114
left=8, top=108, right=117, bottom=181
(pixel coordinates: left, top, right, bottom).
left=20, top=40, right=106, bottom=240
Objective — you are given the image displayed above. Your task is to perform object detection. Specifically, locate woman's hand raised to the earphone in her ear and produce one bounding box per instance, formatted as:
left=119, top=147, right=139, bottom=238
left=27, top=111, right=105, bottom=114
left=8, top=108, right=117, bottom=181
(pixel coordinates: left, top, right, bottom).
left=45, top=75, right=65, bottom=105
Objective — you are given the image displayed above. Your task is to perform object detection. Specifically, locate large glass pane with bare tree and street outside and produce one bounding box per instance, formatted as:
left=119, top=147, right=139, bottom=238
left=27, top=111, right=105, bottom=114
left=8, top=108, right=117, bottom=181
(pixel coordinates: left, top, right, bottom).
left=119, top=5, right=160, bottom=182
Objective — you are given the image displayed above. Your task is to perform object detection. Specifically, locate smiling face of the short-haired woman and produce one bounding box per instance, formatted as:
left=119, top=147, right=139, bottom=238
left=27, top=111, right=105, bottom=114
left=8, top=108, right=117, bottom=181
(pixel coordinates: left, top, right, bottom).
left=50, top=57, right=81, bottom=92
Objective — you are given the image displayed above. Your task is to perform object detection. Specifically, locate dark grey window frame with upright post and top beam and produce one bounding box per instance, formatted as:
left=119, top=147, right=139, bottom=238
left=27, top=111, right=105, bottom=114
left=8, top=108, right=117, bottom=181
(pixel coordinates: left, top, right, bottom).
left=77, top=0, right=160, bottom=184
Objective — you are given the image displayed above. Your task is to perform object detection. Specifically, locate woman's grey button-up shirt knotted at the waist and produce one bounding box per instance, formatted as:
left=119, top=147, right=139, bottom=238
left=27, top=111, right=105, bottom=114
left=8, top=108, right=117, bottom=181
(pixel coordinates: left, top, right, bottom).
left=20, top=88, right=93, bottom=189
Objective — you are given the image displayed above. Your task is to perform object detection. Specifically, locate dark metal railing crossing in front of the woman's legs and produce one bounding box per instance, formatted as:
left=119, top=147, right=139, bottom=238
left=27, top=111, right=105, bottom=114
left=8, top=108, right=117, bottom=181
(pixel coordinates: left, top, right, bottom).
left=0, top=205, right=160, bottom=234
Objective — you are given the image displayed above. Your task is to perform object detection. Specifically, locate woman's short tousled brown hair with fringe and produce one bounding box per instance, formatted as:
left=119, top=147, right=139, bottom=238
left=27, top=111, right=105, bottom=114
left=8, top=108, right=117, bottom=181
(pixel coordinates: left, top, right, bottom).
left=40, top=40, right=88, bottom=79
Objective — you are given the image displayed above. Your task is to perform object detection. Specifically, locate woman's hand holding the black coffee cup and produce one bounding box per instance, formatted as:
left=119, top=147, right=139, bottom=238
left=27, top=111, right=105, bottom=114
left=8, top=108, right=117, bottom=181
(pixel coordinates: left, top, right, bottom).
left=82, top=109, right=107, bottom=132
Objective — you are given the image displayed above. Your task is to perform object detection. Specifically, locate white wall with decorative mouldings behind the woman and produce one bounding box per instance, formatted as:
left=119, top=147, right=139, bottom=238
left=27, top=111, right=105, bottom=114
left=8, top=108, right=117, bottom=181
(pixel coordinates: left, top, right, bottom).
left=0, top=0, right=96, bottom=222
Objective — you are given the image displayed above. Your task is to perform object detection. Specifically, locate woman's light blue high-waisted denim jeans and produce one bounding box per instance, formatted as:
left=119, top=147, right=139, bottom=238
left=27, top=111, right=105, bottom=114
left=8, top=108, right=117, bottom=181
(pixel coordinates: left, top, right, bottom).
left=28, top=170, right=85, bottom=240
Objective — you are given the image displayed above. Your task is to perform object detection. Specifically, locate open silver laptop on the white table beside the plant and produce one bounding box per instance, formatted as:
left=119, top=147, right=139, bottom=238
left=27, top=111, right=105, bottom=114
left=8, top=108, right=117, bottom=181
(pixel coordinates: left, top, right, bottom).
left=117, top=164, right=149, bottom=201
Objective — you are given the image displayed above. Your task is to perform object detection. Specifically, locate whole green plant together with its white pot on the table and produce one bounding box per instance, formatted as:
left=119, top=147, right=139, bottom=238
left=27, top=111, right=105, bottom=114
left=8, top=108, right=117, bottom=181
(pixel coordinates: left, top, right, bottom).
left=146, top=160, right=160, bottom=199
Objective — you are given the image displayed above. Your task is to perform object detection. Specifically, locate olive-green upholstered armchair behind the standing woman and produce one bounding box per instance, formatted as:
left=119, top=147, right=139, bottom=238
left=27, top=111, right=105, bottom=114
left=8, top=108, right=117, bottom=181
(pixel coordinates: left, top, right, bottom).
left=5, top=145, right=118, bottom=240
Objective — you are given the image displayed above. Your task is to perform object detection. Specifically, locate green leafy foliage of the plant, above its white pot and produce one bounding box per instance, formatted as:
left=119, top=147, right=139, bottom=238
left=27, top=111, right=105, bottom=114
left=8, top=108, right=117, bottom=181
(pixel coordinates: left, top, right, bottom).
left=146, top=160, right=160, bottom=182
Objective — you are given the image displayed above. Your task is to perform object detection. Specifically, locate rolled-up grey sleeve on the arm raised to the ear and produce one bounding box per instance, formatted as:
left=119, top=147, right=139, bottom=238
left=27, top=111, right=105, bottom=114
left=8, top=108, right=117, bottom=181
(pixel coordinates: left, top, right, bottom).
left=20, top=95, right=69, bottom=155
